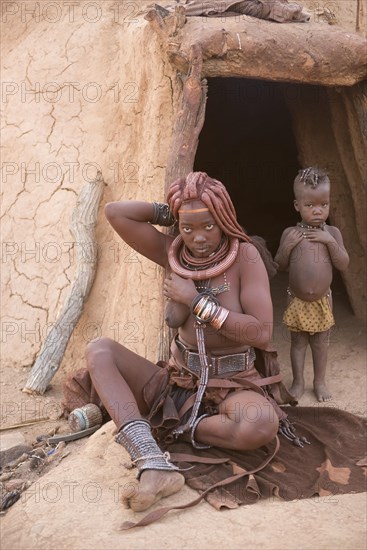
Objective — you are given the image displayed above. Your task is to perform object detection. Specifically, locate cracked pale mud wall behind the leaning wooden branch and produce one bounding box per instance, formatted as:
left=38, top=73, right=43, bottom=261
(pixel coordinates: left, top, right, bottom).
left=1, top=1, right=179, bottom=378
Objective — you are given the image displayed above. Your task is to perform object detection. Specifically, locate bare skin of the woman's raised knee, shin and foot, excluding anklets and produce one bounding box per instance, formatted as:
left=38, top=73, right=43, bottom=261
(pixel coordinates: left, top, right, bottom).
left=86, top=338, right=185, bottom=511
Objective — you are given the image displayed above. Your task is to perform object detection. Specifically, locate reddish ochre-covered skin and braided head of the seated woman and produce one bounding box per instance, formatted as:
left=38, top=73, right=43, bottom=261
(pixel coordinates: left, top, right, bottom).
left=87, top=173, right=279, bottom=510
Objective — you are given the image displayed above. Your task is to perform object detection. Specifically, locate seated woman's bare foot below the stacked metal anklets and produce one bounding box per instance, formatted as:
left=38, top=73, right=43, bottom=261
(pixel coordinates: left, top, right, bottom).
left=122, top=470, right=185, bottom=512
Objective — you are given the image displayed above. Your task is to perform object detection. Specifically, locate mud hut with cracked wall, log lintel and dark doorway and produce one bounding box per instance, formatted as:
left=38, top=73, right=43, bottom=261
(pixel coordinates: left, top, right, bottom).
left=2, top=0, right=367, bottom=390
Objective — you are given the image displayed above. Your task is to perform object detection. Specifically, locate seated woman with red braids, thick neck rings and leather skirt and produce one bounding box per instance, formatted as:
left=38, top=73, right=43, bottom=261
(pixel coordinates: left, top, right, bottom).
left=87, top=172, right=288, bottom=511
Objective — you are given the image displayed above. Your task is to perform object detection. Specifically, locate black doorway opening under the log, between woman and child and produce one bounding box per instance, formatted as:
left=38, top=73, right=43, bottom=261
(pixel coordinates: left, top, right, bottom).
left=194, top=78, right=300, bottom=254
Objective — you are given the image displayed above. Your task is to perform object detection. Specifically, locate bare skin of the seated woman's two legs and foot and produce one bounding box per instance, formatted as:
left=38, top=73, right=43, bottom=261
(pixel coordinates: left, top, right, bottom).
left=87, top=338, right=278, bottom=511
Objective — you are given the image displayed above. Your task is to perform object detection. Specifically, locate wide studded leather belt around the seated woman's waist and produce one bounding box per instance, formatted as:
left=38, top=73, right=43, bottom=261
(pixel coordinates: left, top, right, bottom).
left=176, top=338, right=256, bottom=376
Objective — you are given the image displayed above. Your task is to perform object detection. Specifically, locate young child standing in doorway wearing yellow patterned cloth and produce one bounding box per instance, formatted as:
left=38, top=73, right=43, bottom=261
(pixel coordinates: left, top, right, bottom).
left=275, top=167, right=349, bottom=401
